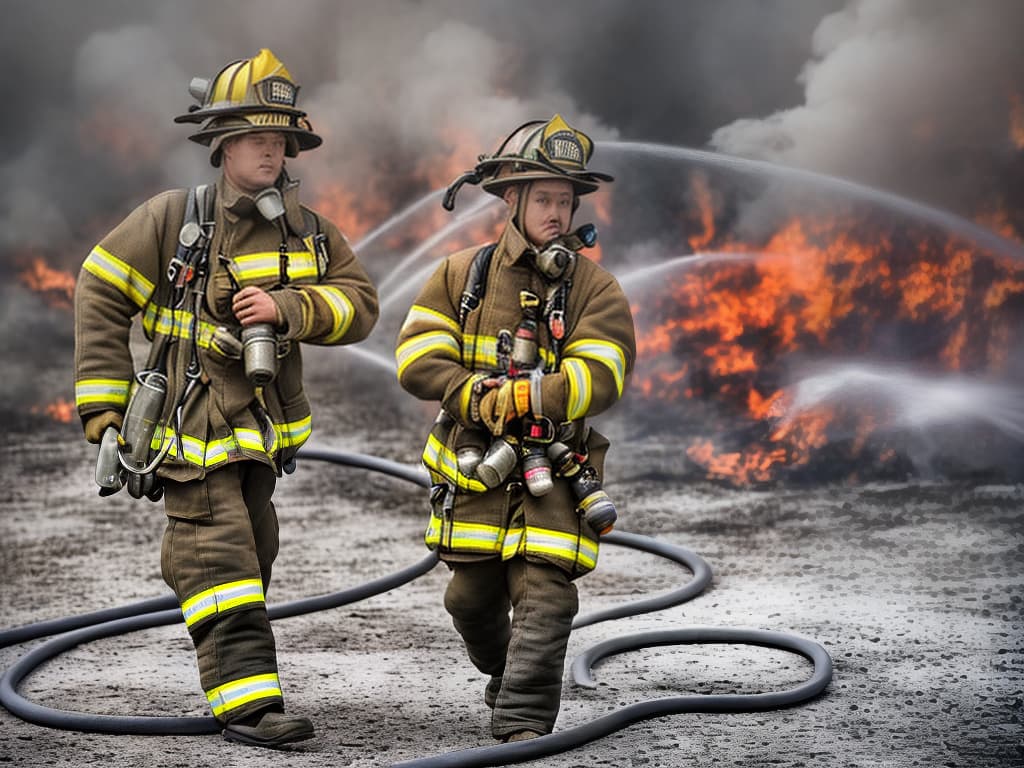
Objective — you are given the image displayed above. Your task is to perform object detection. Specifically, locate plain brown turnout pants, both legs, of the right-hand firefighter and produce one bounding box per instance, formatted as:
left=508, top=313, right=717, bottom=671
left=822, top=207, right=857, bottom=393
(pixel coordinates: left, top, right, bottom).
left=444, top=556, right=579, bottom=738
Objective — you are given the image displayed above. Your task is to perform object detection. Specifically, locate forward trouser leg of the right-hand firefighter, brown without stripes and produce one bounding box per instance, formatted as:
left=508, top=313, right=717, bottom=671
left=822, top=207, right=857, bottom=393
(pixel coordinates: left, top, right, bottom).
left=490, top=557, right=579, bottom=738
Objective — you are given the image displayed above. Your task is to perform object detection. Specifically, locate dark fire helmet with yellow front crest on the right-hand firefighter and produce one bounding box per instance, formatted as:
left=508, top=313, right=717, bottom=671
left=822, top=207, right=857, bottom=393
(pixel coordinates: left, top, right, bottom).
left=441, top=115, right=614, bottom=211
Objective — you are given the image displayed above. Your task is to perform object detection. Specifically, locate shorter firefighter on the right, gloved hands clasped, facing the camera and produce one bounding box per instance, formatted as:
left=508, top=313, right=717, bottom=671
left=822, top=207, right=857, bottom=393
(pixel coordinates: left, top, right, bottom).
left=395, top=115, right=635, bottom=741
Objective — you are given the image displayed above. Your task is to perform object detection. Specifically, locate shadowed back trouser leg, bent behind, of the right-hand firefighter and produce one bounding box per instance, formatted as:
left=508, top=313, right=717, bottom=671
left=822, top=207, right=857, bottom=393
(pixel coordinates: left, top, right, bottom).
left=444, top=558, right=511, bottom=675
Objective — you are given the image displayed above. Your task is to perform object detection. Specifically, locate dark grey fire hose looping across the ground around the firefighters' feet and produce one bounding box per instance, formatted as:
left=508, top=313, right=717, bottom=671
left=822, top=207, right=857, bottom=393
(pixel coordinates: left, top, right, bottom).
left=0, top=447, right=833, bottom=768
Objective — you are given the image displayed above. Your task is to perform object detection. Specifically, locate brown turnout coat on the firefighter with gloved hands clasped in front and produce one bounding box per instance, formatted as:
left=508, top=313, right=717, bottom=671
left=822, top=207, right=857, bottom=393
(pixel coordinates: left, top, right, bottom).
left=395, top=224, right=636, bottom=578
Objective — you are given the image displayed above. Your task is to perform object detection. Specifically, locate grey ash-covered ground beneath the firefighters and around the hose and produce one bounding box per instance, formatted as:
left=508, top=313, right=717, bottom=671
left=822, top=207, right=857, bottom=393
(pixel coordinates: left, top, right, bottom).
left=0, top=353, right=1024, bottom=768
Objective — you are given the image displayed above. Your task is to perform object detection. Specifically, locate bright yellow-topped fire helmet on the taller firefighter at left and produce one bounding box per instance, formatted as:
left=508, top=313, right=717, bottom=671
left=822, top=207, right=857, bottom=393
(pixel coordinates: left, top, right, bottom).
left=174, top=48, right=323, bottom=166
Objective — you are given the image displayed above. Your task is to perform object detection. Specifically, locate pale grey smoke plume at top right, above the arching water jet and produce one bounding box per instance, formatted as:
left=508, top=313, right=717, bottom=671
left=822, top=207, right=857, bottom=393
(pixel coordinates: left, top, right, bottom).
left=711, top=0, right=1024, bottom=215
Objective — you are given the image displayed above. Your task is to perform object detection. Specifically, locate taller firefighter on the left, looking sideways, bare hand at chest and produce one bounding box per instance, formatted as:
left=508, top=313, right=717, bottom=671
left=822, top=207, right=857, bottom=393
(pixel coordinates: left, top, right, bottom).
left=75, top=49, right=378, bottom=748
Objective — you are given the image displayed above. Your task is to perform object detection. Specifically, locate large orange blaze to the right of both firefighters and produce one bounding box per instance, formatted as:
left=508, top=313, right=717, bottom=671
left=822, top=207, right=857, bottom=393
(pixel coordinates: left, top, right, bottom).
left=634, top=175, right=1024, bottom=484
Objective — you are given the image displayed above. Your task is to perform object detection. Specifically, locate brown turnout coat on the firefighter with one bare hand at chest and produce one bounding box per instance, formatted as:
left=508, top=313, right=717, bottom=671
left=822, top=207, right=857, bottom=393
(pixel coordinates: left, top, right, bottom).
left=75, top=177, right=378, bottom=481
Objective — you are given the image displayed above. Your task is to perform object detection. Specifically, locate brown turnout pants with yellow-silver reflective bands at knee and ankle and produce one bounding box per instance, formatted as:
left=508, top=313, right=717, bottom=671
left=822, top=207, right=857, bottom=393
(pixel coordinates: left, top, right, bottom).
left=161, top=461, right=284, bottom=724
